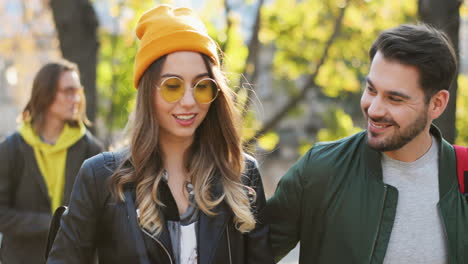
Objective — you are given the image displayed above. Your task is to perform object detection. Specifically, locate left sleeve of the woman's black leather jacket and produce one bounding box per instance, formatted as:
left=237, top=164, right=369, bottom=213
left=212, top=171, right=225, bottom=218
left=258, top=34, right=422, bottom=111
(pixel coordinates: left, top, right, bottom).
left=47, top=156, right=103, bottom=264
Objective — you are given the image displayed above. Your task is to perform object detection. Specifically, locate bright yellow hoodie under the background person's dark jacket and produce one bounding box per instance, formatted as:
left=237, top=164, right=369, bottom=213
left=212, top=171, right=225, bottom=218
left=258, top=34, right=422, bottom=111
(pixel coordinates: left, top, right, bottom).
left=19, top=122, right=86, bottom=212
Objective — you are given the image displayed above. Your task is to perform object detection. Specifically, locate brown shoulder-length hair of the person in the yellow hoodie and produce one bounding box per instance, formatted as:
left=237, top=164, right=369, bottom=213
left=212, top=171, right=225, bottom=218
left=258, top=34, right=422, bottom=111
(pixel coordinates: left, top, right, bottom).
left=21, top=59, right=91, bottom=133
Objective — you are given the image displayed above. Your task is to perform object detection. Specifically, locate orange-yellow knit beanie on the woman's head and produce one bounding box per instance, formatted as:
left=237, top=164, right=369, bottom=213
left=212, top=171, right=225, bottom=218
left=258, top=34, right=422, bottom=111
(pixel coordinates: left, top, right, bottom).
left=133, top=5, right=219, bottom=88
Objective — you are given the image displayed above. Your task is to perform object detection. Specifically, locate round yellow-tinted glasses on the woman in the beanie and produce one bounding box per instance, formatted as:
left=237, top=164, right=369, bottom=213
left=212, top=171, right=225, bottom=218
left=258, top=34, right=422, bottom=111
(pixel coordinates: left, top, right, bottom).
left=158, top=77, right=219, bottom=104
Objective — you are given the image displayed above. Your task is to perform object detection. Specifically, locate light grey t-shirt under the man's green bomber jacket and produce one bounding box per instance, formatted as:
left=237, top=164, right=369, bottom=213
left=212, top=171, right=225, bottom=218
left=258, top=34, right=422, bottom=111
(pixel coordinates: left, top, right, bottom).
left=382, top=138, right=448, bottom=264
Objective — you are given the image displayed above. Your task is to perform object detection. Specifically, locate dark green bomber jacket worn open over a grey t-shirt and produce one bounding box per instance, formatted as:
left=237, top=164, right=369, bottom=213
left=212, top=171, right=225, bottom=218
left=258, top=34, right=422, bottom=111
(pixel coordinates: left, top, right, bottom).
left=267, top=126, right=468, bottom=264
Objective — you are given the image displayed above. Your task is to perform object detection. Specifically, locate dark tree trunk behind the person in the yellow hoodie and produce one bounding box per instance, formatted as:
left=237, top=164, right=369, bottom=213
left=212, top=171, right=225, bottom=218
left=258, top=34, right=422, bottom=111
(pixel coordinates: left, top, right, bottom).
left=50, top=0, right=99, bottom=128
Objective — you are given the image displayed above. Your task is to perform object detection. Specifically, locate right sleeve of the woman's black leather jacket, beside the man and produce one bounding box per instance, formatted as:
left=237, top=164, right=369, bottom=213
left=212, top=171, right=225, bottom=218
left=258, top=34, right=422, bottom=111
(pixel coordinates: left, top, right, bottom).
left=245, top=161, right=274, bottom=264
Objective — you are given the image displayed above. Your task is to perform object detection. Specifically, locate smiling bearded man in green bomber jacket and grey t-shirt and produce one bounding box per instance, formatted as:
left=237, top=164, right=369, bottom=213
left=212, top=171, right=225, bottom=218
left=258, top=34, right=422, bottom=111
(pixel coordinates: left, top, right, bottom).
left=267, top=25, right=468, bottom=264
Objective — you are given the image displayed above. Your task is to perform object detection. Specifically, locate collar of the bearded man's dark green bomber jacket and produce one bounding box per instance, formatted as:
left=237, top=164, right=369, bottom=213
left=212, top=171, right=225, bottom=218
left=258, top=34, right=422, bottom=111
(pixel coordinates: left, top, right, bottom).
left=359, top=124, right=457, bottom=199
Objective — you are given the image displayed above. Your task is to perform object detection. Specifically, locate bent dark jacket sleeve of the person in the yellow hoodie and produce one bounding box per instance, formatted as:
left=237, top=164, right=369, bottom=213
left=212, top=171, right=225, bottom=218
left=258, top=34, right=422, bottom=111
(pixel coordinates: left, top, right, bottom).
left=0, top=134, right=51, bottom=237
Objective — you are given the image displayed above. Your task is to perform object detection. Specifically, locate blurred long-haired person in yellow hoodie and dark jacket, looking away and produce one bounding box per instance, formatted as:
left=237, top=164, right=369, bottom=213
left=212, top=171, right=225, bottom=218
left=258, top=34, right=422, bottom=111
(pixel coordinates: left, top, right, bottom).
left=0, top=60, right=102, bottom=264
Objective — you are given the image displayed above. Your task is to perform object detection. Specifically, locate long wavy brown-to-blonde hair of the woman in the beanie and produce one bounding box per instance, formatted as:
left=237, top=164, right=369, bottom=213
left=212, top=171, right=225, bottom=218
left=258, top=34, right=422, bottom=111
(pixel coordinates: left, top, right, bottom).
left=110, top=54, right=255, bottom=234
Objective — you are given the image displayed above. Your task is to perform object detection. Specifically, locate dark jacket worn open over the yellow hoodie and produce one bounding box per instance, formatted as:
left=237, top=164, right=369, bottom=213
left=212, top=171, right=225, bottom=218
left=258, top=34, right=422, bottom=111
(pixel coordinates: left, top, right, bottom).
left=0, top=132, right=102, bottom=264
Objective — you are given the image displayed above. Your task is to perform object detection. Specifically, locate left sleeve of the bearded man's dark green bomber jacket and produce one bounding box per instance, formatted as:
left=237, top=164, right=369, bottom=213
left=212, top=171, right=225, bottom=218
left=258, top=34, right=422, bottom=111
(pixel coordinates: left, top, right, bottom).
left=266, top=155, right=307, bottom=262
